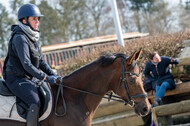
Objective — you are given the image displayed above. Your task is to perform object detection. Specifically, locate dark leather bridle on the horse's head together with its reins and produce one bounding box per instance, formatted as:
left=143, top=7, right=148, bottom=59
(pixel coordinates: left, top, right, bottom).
left=55, top=57, right=147, bottom=116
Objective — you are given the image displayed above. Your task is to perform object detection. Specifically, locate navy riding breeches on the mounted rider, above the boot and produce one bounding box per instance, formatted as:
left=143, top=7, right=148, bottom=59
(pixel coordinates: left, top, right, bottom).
left=5, top=75, right=40, bottom=108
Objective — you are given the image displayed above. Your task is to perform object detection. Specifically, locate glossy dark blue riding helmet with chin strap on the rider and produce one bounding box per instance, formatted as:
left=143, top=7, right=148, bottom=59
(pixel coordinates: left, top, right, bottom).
left=18, top=4, right=44, bottom=29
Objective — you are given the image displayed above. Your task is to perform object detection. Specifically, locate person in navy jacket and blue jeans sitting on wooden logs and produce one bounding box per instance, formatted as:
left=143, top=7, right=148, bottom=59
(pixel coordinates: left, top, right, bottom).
left=144, top=52, right=179, bottom=106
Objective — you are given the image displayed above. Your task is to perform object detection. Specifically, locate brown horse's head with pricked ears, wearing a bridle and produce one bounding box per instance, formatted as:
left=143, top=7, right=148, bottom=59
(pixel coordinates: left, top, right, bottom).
left=111, top=49, right=150, bottom=116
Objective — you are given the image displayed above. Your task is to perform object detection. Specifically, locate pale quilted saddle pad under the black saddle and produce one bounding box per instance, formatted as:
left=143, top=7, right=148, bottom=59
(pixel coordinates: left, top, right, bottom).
left=0, top=84, right=52, bottom=122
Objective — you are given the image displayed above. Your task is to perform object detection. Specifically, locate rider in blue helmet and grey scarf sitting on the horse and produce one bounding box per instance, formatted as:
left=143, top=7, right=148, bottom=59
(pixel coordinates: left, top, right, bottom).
left=3, top=4, right=60, bottom=126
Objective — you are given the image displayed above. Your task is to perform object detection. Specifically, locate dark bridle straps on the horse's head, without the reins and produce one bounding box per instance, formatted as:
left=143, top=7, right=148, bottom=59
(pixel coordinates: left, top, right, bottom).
left=116, top=58, right=147, bottom=107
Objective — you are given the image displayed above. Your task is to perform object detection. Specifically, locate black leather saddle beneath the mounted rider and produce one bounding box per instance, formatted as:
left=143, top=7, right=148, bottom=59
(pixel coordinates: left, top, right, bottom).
left=0, top=79, right=50, bottom=119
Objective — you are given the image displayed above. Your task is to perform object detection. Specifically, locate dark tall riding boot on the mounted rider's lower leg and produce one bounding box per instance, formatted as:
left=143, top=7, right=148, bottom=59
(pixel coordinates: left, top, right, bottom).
left=26, top=104, right=39, bottom=126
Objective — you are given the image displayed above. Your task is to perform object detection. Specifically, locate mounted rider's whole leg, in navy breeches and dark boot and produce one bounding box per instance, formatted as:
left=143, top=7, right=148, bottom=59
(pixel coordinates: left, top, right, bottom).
left=6, top=78, right=40, bottom=126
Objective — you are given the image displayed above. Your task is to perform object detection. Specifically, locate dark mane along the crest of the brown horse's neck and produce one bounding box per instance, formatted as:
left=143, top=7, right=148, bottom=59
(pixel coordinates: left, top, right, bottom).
left=65, top=52, right=127, bottom=78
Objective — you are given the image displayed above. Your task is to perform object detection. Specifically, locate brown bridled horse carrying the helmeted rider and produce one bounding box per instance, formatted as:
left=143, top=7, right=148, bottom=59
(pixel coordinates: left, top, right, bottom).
left=0, top=50, right=150, bottom=126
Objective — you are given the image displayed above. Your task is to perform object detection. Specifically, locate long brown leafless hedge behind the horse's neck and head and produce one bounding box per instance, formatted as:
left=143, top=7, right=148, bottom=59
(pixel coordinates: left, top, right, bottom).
left=62, top=31, right=190, bottom=74
